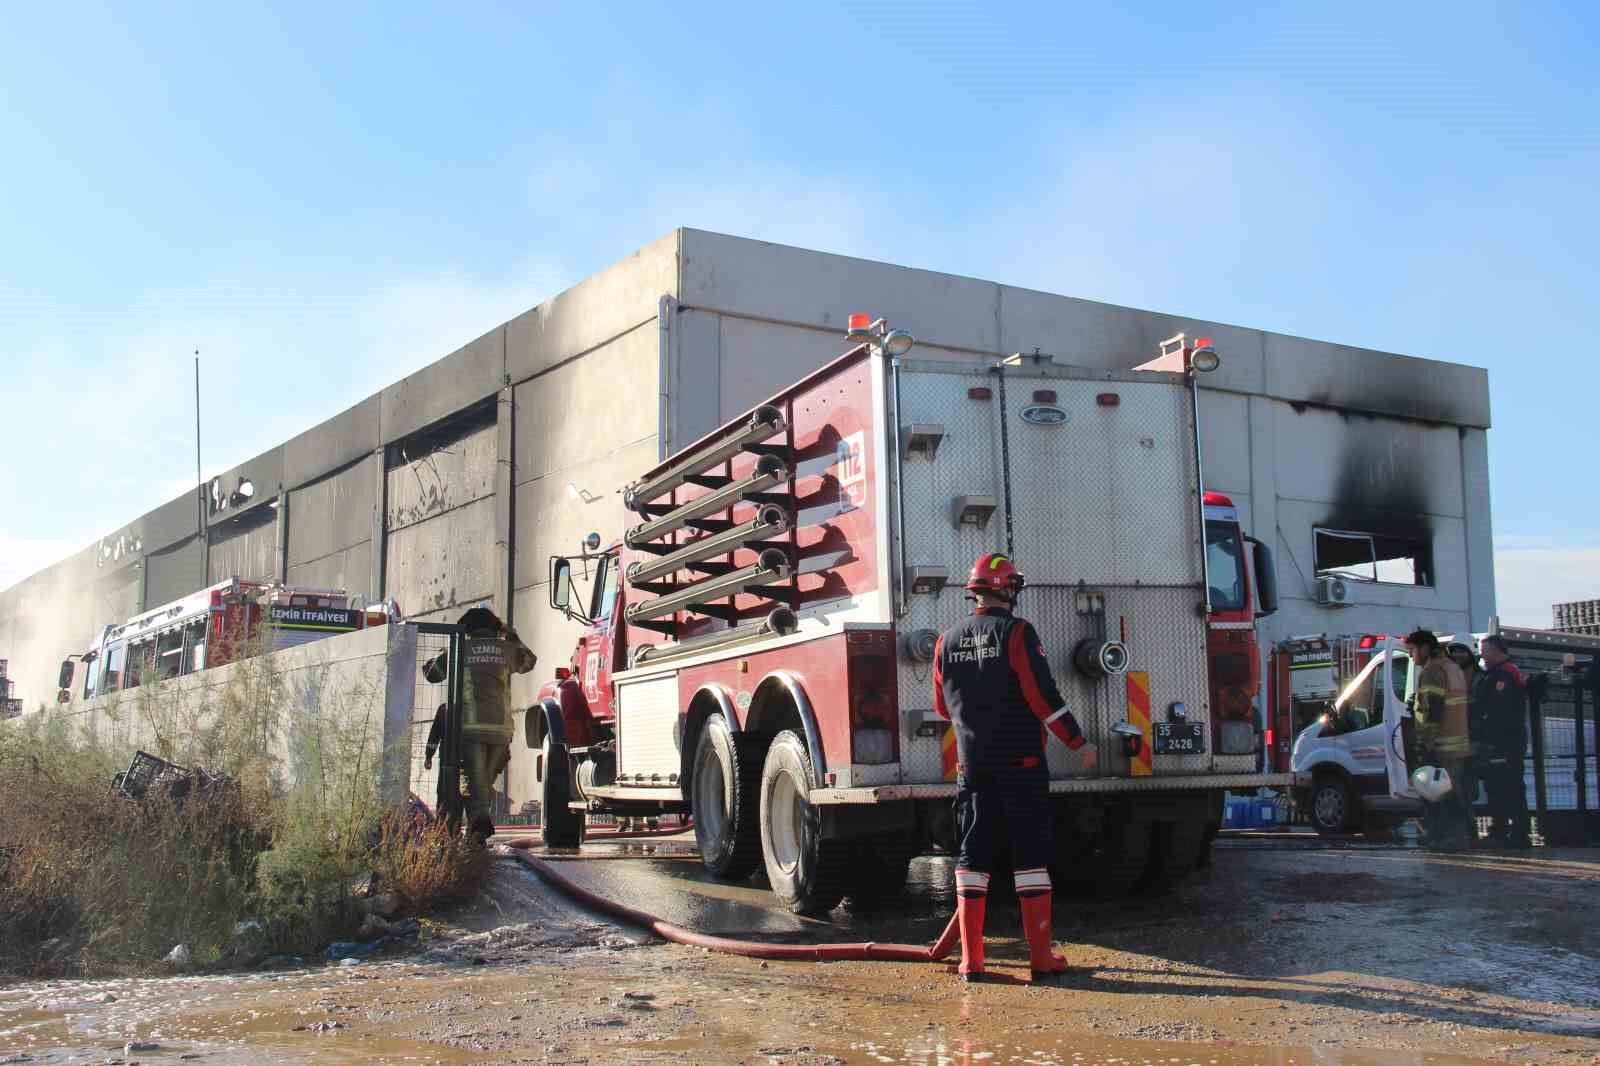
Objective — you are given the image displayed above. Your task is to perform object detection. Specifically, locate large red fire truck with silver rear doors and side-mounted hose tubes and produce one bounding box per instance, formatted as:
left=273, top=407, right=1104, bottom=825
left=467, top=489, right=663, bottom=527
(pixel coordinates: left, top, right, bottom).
left=525, top=315, right=1293, bottom=914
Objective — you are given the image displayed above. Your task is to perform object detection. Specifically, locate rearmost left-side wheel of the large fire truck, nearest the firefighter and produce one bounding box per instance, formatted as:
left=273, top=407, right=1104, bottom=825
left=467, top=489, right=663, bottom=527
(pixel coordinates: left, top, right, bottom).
left=762, top=730, right=848, bottom=916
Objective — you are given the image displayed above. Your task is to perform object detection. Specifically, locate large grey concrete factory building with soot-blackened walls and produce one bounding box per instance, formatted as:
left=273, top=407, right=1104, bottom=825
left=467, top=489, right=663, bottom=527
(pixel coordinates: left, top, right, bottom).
left=0, top=229, right=1494, bottom=800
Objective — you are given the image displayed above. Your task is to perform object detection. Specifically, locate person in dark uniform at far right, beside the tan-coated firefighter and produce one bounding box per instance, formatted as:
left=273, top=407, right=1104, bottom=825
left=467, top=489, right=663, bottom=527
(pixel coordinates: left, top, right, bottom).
left=1472, top=635, right=1531, bottom=848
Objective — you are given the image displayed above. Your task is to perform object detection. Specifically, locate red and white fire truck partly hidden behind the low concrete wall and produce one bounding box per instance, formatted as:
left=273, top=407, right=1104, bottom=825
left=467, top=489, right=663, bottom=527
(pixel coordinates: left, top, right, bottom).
left=58, top=578, right=380, bottom=703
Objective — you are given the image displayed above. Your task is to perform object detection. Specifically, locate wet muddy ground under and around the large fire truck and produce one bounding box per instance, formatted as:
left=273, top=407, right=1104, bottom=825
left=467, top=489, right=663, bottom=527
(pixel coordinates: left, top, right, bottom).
left=0, top=836, right=1600, bottom=1066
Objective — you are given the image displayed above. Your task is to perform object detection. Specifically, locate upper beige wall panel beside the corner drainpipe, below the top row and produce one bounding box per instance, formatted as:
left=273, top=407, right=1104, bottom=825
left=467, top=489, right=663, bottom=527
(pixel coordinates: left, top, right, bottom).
left=515, top=320, right=661, bottom=480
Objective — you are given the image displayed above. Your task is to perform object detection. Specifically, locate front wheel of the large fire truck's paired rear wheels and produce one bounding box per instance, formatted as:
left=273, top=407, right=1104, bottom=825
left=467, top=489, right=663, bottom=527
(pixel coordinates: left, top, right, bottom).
left=690, top=714, right=762, bottom=880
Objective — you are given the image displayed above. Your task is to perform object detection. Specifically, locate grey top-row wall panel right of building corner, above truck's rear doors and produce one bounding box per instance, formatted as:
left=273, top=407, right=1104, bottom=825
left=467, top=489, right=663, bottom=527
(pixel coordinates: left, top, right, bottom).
left=678, top=229, right=1000, bottom=352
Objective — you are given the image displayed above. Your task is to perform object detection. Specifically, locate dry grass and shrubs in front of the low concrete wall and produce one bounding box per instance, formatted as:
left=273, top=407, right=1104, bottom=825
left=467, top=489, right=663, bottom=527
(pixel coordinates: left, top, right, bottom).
left=0, top=643, right=488, bottom=975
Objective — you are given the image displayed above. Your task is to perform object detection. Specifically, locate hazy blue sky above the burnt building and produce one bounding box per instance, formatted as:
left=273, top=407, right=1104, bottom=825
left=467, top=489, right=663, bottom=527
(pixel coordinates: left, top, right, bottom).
left=0, top=3, right=1600, bottom=624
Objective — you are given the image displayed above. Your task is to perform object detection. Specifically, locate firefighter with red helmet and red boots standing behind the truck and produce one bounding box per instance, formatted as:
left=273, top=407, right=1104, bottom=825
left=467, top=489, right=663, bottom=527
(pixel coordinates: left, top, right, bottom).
left=933, top=554, right=1094, bottom=981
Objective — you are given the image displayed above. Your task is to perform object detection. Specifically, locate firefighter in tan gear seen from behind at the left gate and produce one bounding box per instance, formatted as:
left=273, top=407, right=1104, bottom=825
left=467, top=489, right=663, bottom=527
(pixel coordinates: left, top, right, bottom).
left=422, top=607, right=538, bottom=840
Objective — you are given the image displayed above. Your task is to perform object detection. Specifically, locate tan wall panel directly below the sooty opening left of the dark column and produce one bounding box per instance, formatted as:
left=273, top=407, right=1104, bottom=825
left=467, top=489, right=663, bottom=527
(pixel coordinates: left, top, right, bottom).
left=384, top=496, right=494, bottom=618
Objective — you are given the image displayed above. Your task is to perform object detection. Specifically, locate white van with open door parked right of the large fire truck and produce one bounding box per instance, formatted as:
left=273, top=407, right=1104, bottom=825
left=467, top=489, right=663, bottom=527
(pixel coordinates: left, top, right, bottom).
left=1290, top=637, right=1422, bottom=834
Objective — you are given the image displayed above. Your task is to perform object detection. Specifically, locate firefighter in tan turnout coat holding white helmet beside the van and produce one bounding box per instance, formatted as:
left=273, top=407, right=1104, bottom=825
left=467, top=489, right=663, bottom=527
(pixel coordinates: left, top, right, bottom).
left=1405, top=629, right=1477, bottom=850
